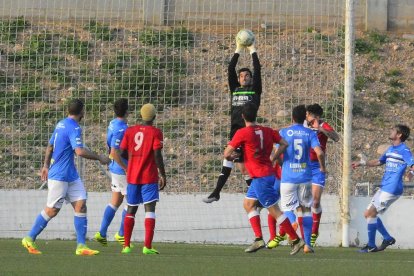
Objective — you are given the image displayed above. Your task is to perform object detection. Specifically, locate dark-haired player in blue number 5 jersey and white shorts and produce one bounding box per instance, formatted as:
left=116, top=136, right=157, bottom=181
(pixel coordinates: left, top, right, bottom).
left=279, top=105, right=325, bottom=253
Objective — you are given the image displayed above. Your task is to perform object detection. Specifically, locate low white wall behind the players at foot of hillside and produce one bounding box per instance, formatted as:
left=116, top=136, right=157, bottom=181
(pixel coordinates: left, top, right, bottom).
left=0, top=190, right=414, bottom=248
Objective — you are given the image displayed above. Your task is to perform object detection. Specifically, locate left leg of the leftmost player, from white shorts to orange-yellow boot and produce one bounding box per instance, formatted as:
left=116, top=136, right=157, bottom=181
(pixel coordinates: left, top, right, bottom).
left=22, top=179, right=68, bottom=254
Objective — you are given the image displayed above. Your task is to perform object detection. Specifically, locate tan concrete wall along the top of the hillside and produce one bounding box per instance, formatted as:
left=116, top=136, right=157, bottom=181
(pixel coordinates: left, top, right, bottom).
left=0, top=0, right=414, bottom=31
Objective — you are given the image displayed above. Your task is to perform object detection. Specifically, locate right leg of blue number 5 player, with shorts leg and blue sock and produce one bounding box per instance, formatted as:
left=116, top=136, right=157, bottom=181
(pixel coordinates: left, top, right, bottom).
left=298, top=183, right=313, bottom=253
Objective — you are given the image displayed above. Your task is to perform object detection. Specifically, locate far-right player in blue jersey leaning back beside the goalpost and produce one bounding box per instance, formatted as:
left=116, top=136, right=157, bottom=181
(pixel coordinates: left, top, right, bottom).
left=352, top=124, right=414, bottom=253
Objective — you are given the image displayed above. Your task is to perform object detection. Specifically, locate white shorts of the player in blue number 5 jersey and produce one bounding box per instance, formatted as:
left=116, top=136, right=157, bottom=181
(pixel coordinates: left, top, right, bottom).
left=280, top=182, right=313, bottom=211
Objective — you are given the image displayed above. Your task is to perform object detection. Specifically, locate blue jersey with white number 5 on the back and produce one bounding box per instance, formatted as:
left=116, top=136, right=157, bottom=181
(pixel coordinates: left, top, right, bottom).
left=279, top=124, right=320, bottom=184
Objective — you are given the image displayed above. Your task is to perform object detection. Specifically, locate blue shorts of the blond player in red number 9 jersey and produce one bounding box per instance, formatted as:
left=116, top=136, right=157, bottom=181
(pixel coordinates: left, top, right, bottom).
left=127, top=183, right=160, bottom=206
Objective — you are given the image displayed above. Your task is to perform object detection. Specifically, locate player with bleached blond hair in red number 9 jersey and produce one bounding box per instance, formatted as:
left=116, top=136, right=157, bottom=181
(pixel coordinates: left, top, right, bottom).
left=120, top=104, right=166, bottom=255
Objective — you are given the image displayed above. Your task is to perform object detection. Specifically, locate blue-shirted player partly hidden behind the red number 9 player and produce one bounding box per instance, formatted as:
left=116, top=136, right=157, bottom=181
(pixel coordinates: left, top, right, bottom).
left=94, top=98, right=128, bottom=246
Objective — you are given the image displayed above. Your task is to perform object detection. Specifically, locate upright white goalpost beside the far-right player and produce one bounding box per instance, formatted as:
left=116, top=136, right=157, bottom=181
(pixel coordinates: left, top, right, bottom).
left=342, top=0, right=355, bottom=247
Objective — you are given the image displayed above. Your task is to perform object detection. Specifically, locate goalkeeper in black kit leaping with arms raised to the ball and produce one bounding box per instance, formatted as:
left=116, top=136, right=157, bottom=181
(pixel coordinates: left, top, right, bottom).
left=203, top=39, right=262, bottom=203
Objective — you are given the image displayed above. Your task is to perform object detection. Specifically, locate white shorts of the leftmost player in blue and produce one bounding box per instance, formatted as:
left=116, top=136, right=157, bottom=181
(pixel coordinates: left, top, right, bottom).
left=46, top=178, right=87, bottom=209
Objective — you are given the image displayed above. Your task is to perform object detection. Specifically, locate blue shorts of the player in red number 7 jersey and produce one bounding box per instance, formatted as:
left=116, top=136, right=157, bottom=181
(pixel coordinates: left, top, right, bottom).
left=246, top=175, right=280, bottom=208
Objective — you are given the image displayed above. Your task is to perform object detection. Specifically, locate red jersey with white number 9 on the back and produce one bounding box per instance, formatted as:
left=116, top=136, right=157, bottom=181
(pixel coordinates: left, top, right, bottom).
left=120, top=125, right=163, bottom=184
